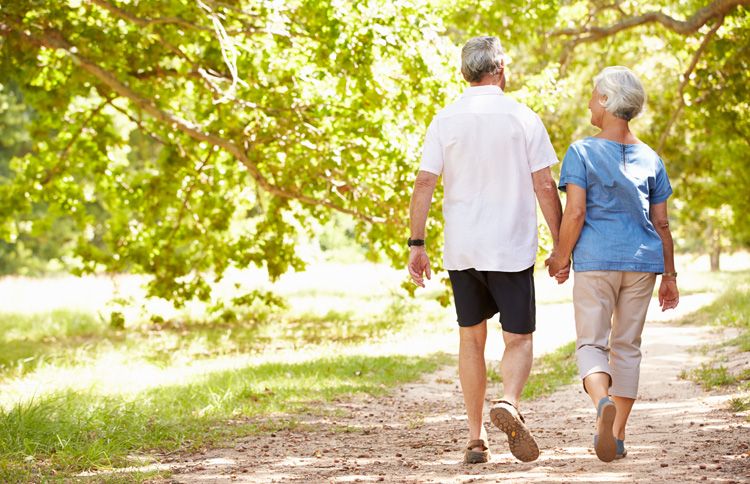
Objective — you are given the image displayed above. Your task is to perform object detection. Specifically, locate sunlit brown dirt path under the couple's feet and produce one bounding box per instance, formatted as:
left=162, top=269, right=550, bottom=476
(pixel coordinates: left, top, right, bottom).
left=162, top=298, right=750, bottom=483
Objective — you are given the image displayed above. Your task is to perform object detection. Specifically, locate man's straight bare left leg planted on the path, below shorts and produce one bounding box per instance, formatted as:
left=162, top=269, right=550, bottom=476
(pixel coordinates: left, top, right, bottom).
left=458, top=320, right=487, bottom=451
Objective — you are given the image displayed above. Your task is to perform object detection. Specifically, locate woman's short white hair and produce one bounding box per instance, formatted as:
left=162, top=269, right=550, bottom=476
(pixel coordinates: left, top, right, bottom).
left=594, top=66, right=646, bottom=121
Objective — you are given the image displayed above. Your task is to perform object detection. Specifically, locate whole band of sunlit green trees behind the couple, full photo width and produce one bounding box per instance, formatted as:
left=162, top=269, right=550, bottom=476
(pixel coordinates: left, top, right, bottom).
left=0, top=0, right=750, bottom=304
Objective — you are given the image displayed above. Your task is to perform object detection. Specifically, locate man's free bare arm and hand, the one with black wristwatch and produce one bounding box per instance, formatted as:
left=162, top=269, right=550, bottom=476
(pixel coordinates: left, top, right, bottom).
left=409, top=170, right=438, bottom=287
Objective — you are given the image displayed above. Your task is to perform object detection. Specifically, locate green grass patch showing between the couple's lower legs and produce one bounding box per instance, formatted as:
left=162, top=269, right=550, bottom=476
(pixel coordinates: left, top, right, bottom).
left=487, top=341, right=578, bottom=400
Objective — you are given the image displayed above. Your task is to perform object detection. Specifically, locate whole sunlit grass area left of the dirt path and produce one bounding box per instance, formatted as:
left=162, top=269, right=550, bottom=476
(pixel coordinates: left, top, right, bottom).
left=0, top=282, right=448, bottom=482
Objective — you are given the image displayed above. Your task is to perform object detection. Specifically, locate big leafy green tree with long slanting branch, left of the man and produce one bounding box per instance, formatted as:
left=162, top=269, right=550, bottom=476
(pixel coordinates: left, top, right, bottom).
left=0, top=0, right=462, bottom=303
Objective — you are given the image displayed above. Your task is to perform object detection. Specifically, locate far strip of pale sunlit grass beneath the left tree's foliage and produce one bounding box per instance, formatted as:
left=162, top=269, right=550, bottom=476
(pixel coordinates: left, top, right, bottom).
left=0, top=294, right=417, bottom=380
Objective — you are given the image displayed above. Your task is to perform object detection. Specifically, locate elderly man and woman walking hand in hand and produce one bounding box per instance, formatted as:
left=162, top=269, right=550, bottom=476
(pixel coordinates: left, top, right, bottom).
left=408, top=37, right=679, bottom=463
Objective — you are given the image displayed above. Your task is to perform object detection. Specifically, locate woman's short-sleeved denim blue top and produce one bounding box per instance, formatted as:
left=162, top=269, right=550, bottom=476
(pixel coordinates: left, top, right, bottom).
left=559, top=138, right=672, bottom=273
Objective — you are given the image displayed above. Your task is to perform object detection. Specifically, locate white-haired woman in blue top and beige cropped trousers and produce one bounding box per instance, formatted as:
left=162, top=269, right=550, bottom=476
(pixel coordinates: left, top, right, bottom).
left=547, top=66, right=679, bottom=462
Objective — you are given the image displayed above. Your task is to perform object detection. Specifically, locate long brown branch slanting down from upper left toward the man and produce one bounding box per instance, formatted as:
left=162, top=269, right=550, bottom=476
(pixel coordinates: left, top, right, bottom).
left=5, top=19, right=385, bottom=223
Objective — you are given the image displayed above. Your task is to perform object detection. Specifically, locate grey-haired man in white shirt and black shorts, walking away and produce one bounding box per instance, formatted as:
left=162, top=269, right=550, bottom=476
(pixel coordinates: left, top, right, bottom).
left=408, top=37, right=562, bottom=463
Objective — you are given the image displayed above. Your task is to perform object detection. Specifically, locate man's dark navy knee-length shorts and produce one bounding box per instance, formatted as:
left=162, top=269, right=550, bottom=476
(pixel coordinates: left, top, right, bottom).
left=448, top=266, right=536, bottom=334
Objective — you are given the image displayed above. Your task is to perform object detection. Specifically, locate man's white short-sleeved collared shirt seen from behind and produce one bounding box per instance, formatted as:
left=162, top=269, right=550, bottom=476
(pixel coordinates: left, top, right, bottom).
left=419, top=86, right=558, bottom=272
